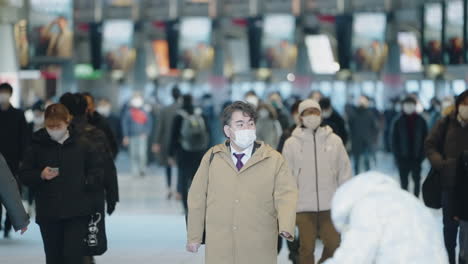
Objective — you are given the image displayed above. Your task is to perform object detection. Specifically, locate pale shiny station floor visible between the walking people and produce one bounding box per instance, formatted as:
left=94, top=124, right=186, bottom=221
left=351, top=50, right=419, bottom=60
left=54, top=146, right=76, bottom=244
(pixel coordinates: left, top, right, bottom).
left=0, top=154, right=436, bottom=264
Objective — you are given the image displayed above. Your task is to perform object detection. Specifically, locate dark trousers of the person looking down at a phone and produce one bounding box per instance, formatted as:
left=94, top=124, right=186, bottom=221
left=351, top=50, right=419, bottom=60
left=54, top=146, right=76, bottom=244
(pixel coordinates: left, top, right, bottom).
left=39, top=217, right=88, bottom=264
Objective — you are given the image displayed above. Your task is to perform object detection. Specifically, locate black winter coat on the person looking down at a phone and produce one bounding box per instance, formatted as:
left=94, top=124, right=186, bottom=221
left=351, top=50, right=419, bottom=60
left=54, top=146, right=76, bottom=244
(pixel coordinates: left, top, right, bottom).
left=19, top=128, right=104, bottom=223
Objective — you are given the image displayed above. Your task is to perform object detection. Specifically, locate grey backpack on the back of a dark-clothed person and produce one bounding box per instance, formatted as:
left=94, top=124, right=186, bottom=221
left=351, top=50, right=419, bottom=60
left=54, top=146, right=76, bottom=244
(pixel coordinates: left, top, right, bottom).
left=180, top=112, right=209, bottom=152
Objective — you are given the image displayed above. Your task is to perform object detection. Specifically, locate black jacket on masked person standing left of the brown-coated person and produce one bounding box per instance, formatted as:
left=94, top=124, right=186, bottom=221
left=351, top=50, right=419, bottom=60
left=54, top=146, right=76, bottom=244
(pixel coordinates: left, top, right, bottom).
left=391, top=114, right=428, bottom=162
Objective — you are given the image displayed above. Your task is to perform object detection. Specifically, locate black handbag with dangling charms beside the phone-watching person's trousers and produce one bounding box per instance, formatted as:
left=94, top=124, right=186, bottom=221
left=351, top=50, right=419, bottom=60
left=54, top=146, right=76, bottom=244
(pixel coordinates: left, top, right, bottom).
left=83, top=211, right=107, bottom=256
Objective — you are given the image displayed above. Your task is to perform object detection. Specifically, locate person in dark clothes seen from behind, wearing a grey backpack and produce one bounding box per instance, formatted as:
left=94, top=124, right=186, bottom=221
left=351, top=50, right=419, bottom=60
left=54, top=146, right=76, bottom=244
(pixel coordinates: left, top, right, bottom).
left=169, top=95, right=210, bottom=214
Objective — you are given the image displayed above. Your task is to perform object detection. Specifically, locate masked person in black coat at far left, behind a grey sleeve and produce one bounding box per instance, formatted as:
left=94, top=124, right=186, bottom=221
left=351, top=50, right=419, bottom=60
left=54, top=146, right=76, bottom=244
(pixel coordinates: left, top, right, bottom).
left=0, top=83, right=30, bottom=238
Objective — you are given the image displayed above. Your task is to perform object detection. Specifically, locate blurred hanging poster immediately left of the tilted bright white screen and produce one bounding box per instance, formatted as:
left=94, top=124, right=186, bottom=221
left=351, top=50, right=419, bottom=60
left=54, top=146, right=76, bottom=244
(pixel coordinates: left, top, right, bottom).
left=261, top=14, right=297, bottom=69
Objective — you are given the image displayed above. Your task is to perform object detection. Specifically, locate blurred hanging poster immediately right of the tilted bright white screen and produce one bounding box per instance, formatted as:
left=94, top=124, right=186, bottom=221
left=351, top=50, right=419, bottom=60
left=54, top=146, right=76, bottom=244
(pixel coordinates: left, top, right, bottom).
left=352, top=13, right=388, bottom=72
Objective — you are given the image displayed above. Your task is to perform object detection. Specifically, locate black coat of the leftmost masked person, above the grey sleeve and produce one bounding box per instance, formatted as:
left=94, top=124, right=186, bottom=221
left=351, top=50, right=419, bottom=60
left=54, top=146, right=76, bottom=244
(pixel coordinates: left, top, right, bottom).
left=0, top=106, right=31, bottom=173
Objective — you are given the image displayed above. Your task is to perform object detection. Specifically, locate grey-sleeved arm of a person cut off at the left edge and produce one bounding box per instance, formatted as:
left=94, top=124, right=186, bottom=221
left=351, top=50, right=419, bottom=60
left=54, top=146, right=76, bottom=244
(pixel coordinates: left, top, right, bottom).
left=0, top=153, right=29, bottom=234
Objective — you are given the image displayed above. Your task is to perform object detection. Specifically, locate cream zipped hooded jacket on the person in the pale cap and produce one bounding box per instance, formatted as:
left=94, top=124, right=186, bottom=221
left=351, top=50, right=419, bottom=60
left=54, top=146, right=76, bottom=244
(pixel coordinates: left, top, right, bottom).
left=283, top=126, right=352, bottom=213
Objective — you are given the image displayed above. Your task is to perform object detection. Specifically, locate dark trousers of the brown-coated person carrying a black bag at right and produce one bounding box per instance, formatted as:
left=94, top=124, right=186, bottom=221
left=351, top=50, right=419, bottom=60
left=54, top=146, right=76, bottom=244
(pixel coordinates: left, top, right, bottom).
left=442, top=190, right=459, bottom=264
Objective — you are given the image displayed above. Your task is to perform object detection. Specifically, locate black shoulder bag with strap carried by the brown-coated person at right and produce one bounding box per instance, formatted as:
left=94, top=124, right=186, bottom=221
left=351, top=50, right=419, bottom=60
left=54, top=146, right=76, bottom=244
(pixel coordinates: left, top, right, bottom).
left=422, top=117, right=450, bottom=209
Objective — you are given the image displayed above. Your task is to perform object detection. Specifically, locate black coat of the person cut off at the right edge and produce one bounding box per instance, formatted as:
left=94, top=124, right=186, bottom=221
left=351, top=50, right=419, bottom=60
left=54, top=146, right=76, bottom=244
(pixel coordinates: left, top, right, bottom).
left=453, top=151, right=468, bottom=221
